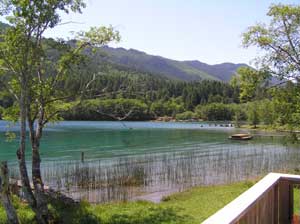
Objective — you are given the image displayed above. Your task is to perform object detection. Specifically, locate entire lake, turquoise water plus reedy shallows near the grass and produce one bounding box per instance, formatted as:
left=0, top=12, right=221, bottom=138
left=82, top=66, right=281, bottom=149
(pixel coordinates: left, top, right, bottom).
left=0, top=121, right=300, bottom=202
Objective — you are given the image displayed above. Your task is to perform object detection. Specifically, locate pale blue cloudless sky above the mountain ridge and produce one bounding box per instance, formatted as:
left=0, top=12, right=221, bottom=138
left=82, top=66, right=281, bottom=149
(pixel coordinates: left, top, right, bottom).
left=4, top=0, right=300, bottom=64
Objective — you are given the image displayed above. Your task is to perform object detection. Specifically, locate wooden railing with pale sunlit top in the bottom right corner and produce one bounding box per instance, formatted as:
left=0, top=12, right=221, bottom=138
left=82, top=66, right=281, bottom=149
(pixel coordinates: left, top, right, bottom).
left=203, top=173, right=300, bottom=224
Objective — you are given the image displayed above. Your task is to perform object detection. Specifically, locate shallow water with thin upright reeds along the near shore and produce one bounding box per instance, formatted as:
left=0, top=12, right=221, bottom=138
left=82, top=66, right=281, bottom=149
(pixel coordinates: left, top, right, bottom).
left=8, top=142, right=300, bottom=203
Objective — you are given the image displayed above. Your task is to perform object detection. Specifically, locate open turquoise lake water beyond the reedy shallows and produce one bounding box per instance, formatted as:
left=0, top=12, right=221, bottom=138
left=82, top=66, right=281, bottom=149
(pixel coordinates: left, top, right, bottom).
left=0, top=121, right=254, bottom=161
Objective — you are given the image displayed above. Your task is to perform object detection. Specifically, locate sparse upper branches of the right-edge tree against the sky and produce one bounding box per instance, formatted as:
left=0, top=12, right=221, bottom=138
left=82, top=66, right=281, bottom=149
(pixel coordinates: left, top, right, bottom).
left=243, top=4, right=300, bottom=79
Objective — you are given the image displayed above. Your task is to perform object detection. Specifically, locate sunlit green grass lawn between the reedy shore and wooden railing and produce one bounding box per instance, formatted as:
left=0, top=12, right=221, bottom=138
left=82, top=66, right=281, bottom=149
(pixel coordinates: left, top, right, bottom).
left=0, top=182, right=300, bottom=224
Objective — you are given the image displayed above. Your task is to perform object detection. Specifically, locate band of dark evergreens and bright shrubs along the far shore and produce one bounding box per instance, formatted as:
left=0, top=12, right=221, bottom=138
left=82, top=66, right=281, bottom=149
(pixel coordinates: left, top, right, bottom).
left=0, top=65, right=239, bottom=120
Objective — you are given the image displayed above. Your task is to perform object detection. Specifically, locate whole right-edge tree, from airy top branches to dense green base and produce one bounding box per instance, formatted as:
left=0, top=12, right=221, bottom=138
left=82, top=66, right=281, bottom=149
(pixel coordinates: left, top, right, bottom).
left=239, top=4, right=300, bottom=130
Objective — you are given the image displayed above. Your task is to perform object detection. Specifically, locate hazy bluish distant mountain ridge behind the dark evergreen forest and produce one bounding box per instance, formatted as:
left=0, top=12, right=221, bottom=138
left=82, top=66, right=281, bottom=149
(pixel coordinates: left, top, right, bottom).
left=101, top=46, right=248, bottom=82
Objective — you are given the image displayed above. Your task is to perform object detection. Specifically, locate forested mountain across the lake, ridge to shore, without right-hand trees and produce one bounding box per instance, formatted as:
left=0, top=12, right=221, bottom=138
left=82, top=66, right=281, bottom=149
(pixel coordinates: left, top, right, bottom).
left=0, top=21, right=243, bottom=120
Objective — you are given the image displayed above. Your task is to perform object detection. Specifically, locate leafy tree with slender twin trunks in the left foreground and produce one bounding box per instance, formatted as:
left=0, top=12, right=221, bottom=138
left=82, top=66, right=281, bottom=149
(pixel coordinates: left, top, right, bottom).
left=0, top=0, right=120, bottom=223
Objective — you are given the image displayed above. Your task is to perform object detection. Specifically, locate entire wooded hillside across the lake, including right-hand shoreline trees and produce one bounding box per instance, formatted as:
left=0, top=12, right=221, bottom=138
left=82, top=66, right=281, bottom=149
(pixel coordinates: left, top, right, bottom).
left=0, top=14, right=299, bottom=129
